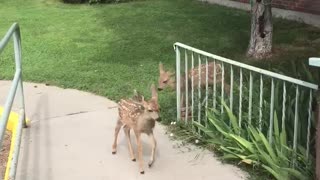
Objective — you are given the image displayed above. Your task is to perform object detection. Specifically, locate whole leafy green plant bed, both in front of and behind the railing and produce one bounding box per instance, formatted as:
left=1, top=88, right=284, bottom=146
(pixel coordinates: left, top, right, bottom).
left=171, top=58, right=316, bottom=179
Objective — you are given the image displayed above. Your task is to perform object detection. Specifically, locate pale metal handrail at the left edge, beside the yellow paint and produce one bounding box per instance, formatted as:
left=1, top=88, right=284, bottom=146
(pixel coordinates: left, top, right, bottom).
left=0, top=23, right=26, bottom=180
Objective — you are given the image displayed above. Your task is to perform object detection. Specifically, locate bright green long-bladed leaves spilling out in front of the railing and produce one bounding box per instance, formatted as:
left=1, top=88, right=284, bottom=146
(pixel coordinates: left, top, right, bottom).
left=194, top=103, right=313, bottom=180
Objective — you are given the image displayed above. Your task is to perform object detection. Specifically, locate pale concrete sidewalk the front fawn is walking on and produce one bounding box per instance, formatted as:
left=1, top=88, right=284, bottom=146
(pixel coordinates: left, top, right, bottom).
left=0, top=81, right=246, bottom=180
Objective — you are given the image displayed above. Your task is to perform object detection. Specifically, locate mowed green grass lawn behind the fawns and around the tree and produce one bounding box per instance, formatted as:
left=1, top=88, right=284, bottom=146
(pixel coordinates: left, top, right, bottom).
left=0, top=0, right=320, bottom=100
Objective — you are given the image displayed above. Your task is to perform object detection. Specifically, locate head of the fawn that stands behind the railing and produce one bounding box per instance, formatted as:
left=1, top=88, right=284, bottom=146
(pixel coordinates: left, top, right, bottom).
left=158, top=63, right=175, bottom=91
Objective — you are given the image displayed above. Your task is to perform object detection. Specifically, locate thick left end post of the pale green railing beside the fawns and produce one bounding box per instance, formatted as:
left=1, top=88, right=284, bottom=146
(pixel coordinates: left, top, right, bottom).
left=175, top=46, right=181, bottom=121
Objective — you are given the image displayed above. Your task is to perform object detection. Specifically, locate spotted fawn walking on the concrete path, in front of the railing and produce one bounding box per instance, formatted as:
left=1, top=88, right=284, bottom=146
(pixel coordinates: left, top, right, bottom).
left=112, top=84, right=160, bottom=174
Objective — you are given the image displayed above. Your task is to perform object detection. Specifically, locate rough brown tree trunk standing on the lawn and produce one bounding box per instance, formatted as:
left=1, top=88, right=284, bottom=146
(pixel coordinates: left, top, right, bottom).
left=247, top=0, right=273, bottom=59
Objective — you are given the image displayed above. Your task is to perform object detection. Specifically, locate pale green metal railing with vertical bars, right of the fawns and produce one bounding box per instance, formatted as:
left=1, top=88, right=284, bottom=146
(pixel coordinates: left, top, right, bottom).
left=174, top=43, right=320, bottom=163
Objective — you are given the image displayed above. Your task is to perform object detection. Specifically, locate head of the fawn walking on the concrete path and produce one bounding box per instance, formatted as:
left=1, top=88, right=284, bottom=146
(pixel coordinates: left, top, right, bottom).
left=142, top=84, right=160, bottom=121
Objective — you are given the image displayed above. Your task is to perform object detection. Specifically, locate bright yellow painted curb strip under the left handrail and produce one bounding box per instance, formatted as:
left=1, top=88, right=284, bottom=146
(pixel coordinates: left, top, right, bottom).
left=0, top=107, right=30, bottom=180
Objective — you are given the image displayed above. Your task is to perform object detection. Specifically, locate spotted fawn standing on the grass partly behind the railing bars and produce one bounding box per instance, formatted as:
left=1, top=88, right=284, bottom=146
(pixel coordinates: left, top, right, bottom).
left=158, top=62, right=230, bottom=119
